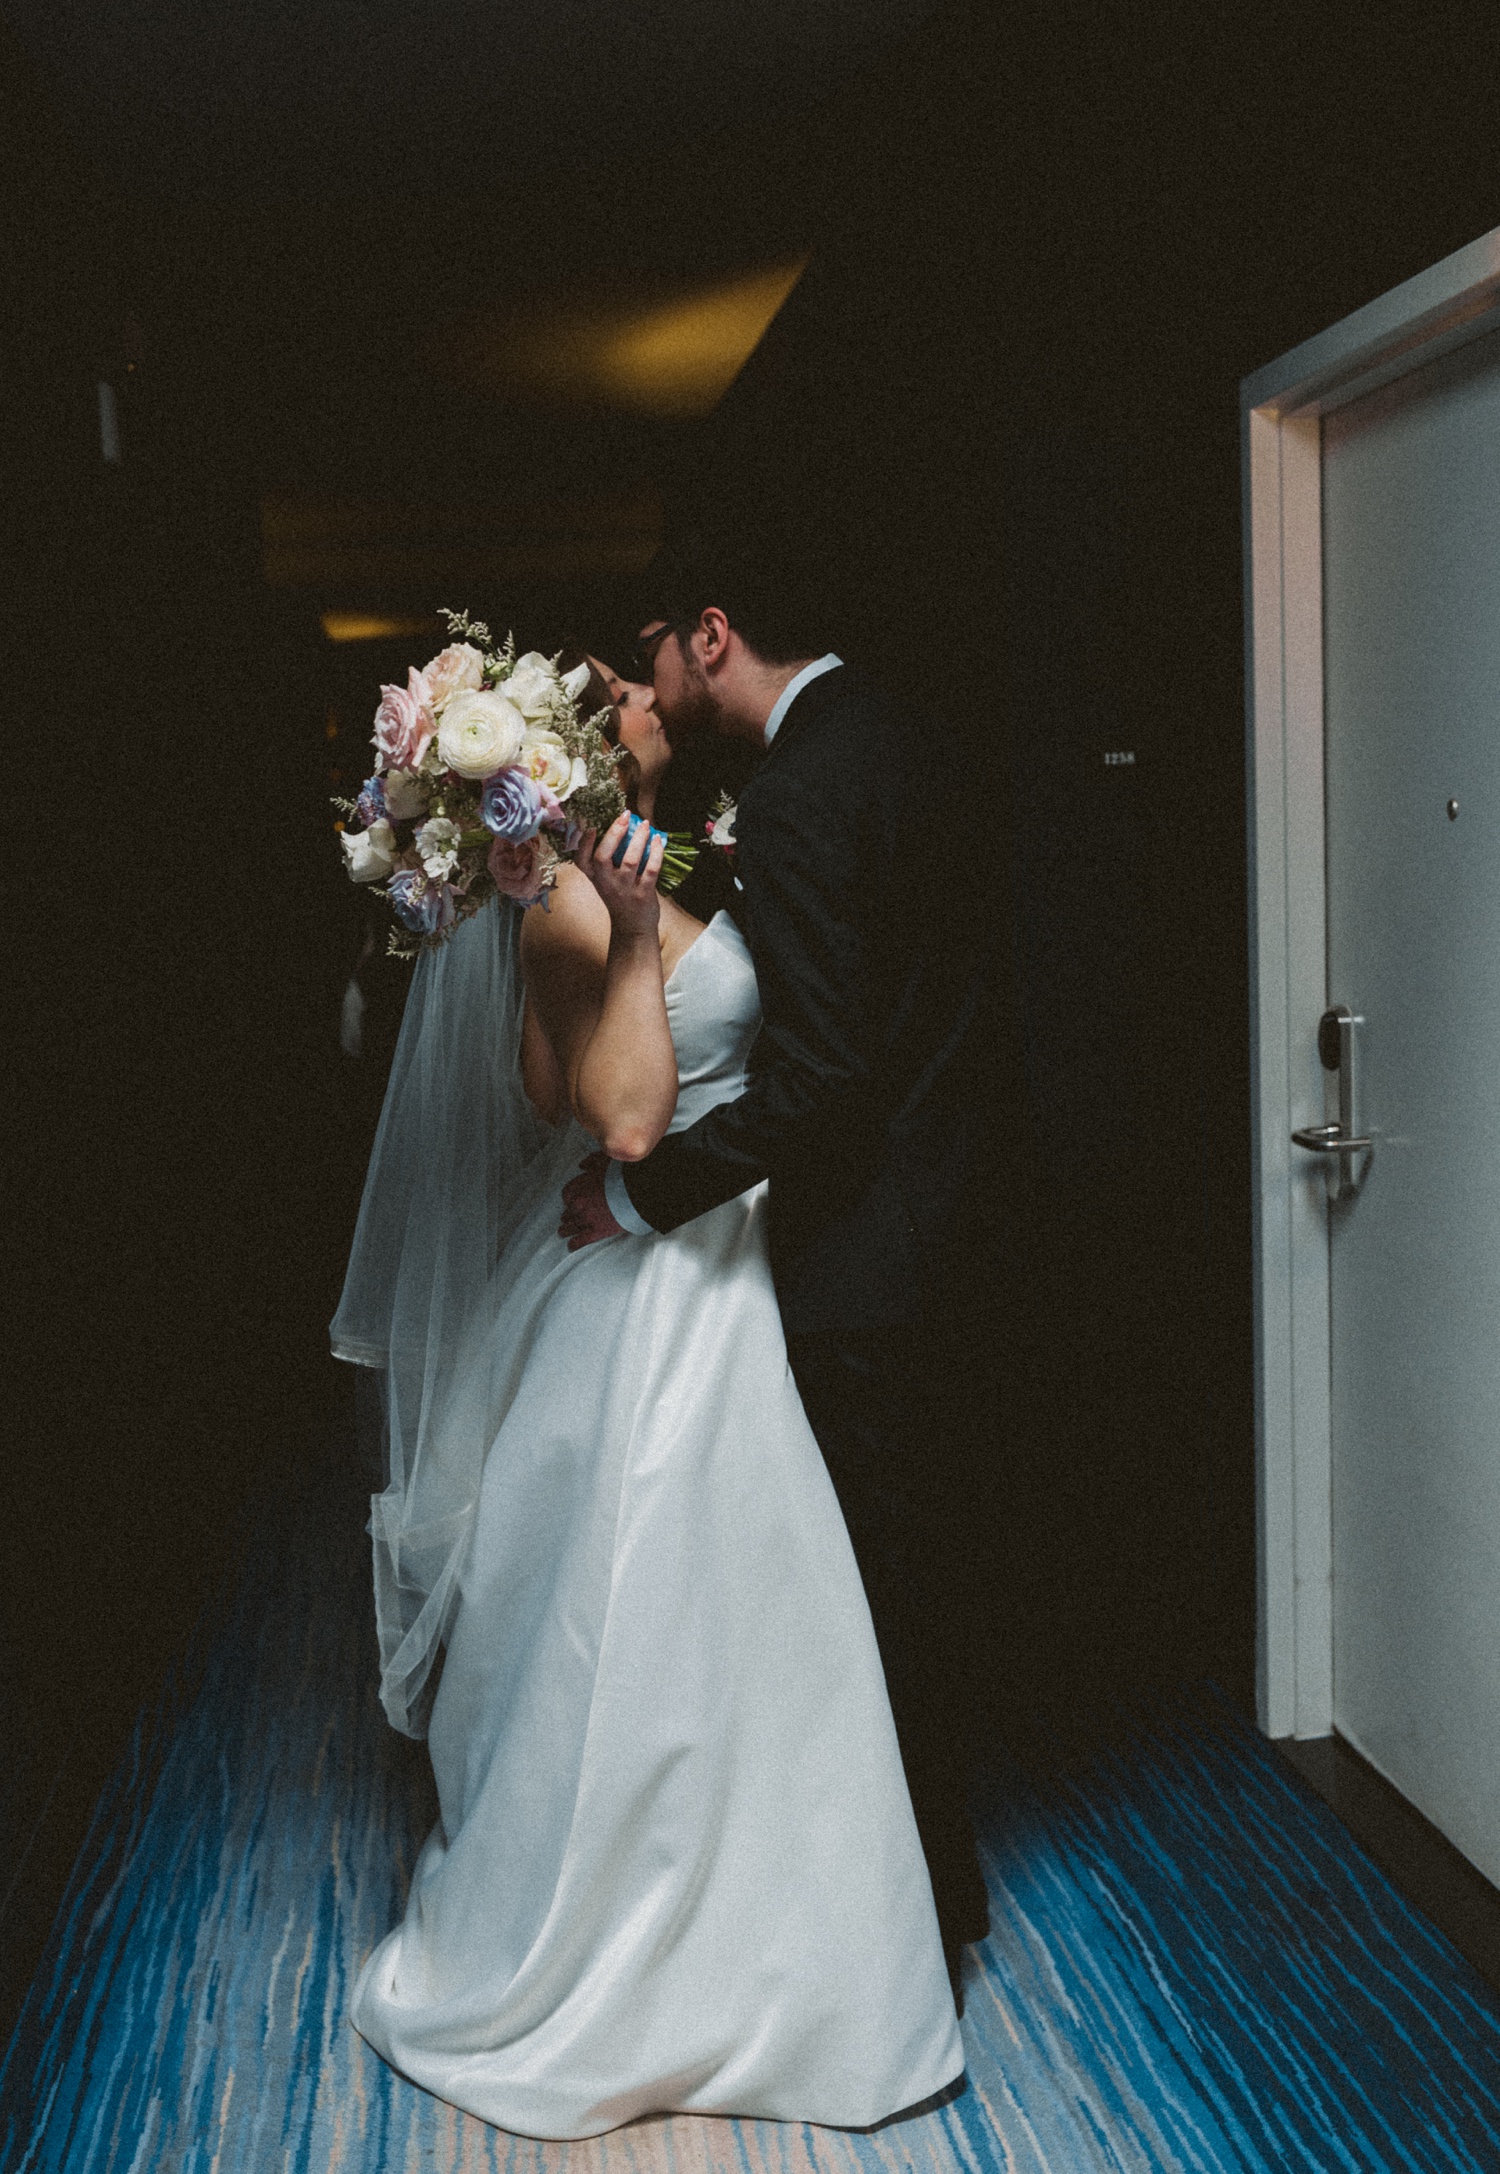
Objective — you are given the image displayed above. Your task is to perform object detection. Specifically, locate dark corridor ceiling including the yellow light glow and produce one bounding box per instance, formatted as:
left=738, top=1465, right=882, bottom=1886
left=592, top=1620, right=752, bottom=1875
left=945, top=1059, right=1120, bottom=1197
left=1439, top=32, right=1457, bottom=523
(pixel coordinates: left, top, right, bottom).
left=0, top=0, right=956, bottom=628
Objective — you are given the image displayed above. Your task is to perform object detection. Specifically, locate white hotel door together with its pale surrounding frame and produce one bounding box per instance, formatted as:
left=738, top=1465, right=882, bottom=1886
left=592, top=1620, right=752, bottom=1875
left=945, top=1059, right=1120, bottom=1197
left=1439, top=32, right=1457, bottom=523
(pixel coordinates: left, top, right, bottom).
left=1248, top=225, right=1500, bottom=1883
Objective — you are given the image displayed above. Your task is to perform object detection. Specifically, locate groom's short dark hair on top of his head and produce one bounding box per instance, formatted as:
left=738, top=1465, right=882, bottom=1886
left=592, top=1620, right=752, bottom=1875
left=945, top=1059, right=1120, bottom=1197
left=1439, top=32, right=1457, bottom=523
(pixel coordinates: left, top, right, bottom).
left=639, top=528, right=828, bottom=665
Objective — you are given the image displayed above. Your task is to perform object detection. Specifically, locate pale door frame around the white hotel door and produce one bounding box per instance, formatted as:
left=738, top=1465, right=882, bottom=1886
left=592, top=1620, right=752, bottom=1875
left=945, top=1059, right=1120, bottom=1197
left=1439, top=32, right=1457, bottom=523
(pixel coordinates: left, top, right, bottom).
left=1239, top=226, right=1500, bottom=1737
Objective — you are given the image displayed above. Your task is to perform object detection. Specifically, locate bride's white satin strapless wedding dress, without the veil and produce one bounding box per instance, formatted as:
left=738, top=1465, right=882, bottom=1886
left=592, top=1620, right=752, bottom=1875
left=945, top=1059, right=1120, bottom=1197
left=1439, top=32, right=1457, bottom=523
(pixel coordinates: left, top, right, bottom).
left=352, top=915, right=963, bottom=2137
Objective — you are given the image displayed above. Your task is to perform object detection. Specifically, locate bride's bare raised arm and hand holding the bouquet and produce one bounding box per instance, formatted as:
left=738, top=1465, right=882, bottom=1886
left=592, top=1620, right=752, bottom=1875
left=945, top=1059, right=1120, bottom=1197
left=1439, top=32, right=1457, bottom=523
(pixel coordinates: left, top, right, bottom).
left=522, top=820, right=676, bottom=1163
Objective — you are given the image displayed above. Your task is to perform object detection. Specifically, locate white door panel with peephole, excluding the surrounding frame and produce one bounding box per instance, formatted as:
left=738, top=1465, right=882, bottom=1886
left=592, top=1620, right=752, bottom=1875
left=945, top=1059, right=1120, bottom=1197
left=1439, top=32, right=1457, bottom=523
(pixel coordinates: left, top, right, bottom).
left=1309, top=333, right=1500, bottom=1881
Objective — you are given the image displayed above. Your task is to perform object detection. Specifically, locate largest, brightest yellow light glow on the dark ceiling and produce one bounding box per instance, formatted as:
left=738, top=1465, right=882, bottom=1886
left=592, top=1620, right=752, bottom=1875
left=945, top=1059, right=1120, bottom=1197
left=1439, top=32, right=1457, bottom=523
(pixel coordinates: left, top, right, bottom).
left=426, top=257, right=807, bottom=415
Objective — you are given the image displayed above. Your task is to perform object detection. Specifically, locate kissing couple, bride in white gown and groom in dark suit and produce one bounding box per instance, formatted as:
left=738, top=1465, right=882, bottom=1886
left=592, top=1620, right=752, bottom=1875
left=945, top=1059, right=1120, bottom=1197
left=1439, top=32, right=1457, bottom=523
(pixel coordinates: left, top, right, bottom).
left=335, top=534, right=996, bottom=2137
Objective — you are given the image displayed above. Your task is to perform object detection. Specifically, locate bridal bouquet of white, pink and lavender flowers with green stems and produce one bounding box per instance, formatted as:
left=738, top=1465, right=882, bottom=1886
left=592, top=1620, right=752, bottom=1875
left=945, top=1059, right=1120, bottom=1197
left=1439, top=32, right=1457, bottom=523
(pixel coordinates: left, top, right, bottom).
left=335, top=611, right=691, bottom=959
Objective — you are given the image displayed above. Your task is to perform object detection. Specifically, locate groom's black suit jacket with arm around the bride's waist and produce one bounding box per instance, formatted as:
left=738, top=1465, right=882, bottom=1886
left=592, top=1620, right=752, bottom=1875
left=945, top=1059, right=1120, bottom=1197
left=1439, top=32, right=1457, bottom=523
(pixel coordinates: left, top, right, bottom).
left=624, top=665, right=1020, bottom=1335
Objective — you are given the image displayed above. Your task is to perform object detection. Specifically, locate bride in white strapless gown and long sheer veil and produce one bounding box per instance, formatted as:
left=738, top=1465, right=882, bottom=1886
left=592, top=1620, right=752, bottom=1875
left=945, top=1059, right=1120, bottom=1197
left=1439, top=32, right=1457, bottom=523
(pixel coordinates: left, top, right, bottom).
left=333, top=652, right=963, bottom=2137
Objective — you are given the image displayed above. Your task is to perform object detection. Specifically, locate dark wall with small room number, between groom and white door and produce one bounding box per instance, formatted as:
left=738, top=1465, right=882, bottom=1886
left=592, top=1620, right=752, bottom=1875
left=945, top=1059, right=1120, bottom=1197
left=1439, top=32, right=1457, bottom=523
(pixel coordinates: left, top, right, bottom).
left=685, top=4, right=1500, bottom=1698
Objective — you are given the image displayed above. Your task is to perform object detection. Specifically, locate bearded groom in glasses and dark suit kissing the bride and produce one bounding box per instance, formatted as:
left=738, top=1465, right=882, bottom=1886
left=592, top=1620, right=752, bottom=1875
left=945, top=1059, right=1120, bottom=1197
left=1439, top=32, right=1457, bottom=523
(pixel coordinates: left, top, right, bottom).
left=563, top=546, right=1017, bottom=1991
